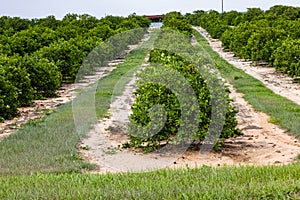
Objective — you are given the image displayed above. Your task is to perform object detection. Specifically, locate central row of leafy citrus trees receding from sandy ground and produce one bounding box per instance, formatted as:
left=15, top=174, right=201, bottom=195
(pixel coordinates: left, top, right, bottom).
left=127, top=12, right=239, bottom=152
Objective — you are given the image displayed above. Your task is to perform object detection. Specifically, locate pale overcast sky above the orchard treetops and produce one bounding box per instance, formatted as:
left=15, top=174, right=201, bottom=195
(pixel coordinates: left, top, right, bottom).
left=0, top=0, right=300, bottom=19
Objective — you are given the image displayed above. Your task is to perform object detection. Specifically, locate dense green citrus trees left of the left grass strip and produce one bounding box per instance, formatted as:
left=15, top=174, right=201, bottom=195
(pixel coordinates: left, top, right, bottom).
left=0, top=14, right=150, bottom=120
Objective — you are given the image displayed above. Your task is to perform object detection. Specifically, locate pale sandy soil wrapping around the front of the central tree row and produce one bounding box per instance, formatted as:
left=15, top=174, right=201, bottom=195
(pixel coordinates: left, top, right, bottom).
left=80, top=28, right=300, bottom=173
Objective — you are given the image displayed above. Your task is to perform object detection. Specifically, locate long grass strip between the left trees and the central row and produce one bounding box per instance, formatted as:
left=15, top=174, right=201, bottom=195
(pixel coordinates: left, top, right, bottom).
left=0, top=33, right=153, bottom=176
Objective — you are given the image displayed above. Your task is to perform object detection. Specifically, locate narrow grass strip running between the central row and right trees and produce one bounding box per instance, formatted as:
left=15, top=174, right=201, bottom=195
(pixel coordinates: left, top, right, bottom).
left=194, top=31, right=300, bottom=137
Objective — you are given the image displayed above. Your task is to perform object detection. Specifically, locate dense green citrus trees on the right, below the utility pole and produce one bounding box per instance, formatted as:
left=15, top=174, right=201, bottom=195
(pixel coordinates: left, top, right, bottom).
left=186, top=5, right=300, bottom=77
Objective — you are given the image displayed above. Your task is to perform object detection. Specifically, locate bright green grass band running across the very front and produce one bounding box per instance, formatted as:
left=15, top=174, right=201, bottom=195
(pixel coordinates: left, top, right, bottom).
left=0, top=164, right=300, bottom=200
